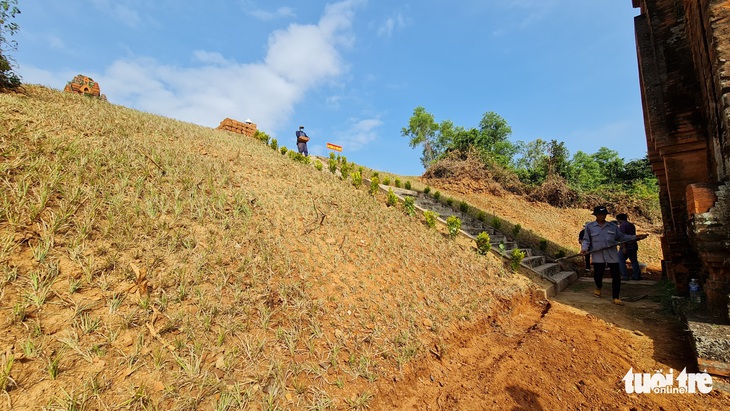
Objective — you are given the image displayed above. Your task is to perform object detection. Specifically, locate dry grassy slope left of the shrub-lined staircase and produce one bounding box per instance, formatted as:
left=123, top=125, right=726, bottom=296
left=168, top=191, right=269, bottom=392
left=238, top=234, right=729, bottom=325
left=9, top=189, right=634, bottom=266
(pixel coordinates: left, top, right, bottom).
left=0, top=86, right=529, bottom=410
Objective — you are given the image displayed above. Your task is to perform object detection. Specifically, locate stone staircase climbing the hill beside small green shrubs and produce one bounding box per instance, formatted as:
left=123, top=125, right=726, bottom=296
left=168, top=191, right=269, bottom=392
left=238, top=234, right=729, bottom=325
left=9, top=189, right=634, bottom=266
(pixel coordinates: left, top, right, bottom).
left=384, top=182, right=578, bottom=297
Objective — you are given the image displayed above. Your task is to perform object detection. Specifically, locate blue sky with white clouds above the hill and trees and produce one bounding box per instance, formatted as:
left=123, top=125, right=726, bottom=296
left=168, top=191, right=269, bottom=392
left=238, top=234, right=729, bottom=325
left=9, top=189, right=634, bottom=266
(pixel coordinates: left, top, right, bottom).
left=11, top=0, right=646, bottom=175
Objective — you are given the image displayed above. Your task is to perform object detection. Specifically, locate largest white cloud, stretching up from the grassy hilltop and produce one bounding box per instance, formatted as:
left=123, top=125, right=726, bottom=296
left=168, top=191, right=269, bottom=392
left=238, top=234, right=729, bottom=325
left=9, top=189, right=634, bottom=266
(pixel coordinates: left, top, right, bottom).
left=69, top=0, right=362, bottom=135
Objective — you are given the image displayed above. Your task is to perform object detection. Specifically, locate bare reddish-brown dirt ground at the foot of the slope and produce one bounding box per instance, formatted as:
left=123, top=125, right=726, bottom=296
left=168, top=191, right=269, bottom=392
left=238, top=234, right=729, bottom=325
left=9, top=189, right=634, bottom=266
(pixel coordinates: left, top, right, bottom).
left=372, top=278, right=730, bottom=410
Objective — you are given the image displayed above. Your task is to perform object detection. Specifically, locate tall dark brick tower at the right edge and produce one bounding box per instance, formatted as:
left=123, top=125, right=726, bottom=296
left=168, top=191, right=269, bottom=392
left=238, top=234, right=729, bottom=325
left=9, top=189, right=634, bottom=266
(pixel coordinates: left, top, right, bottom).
left=632, top=0, right=730, bottom=321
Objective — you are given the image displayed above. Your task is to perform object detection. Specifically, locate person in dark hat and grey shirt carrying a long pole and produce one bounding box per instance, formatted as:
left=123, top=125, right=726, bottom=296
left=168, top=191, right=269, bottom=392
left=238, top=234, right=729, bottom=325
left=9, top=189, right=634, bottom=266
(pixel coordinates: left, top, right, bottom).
left=580, top=206, right=646, bottom=305
